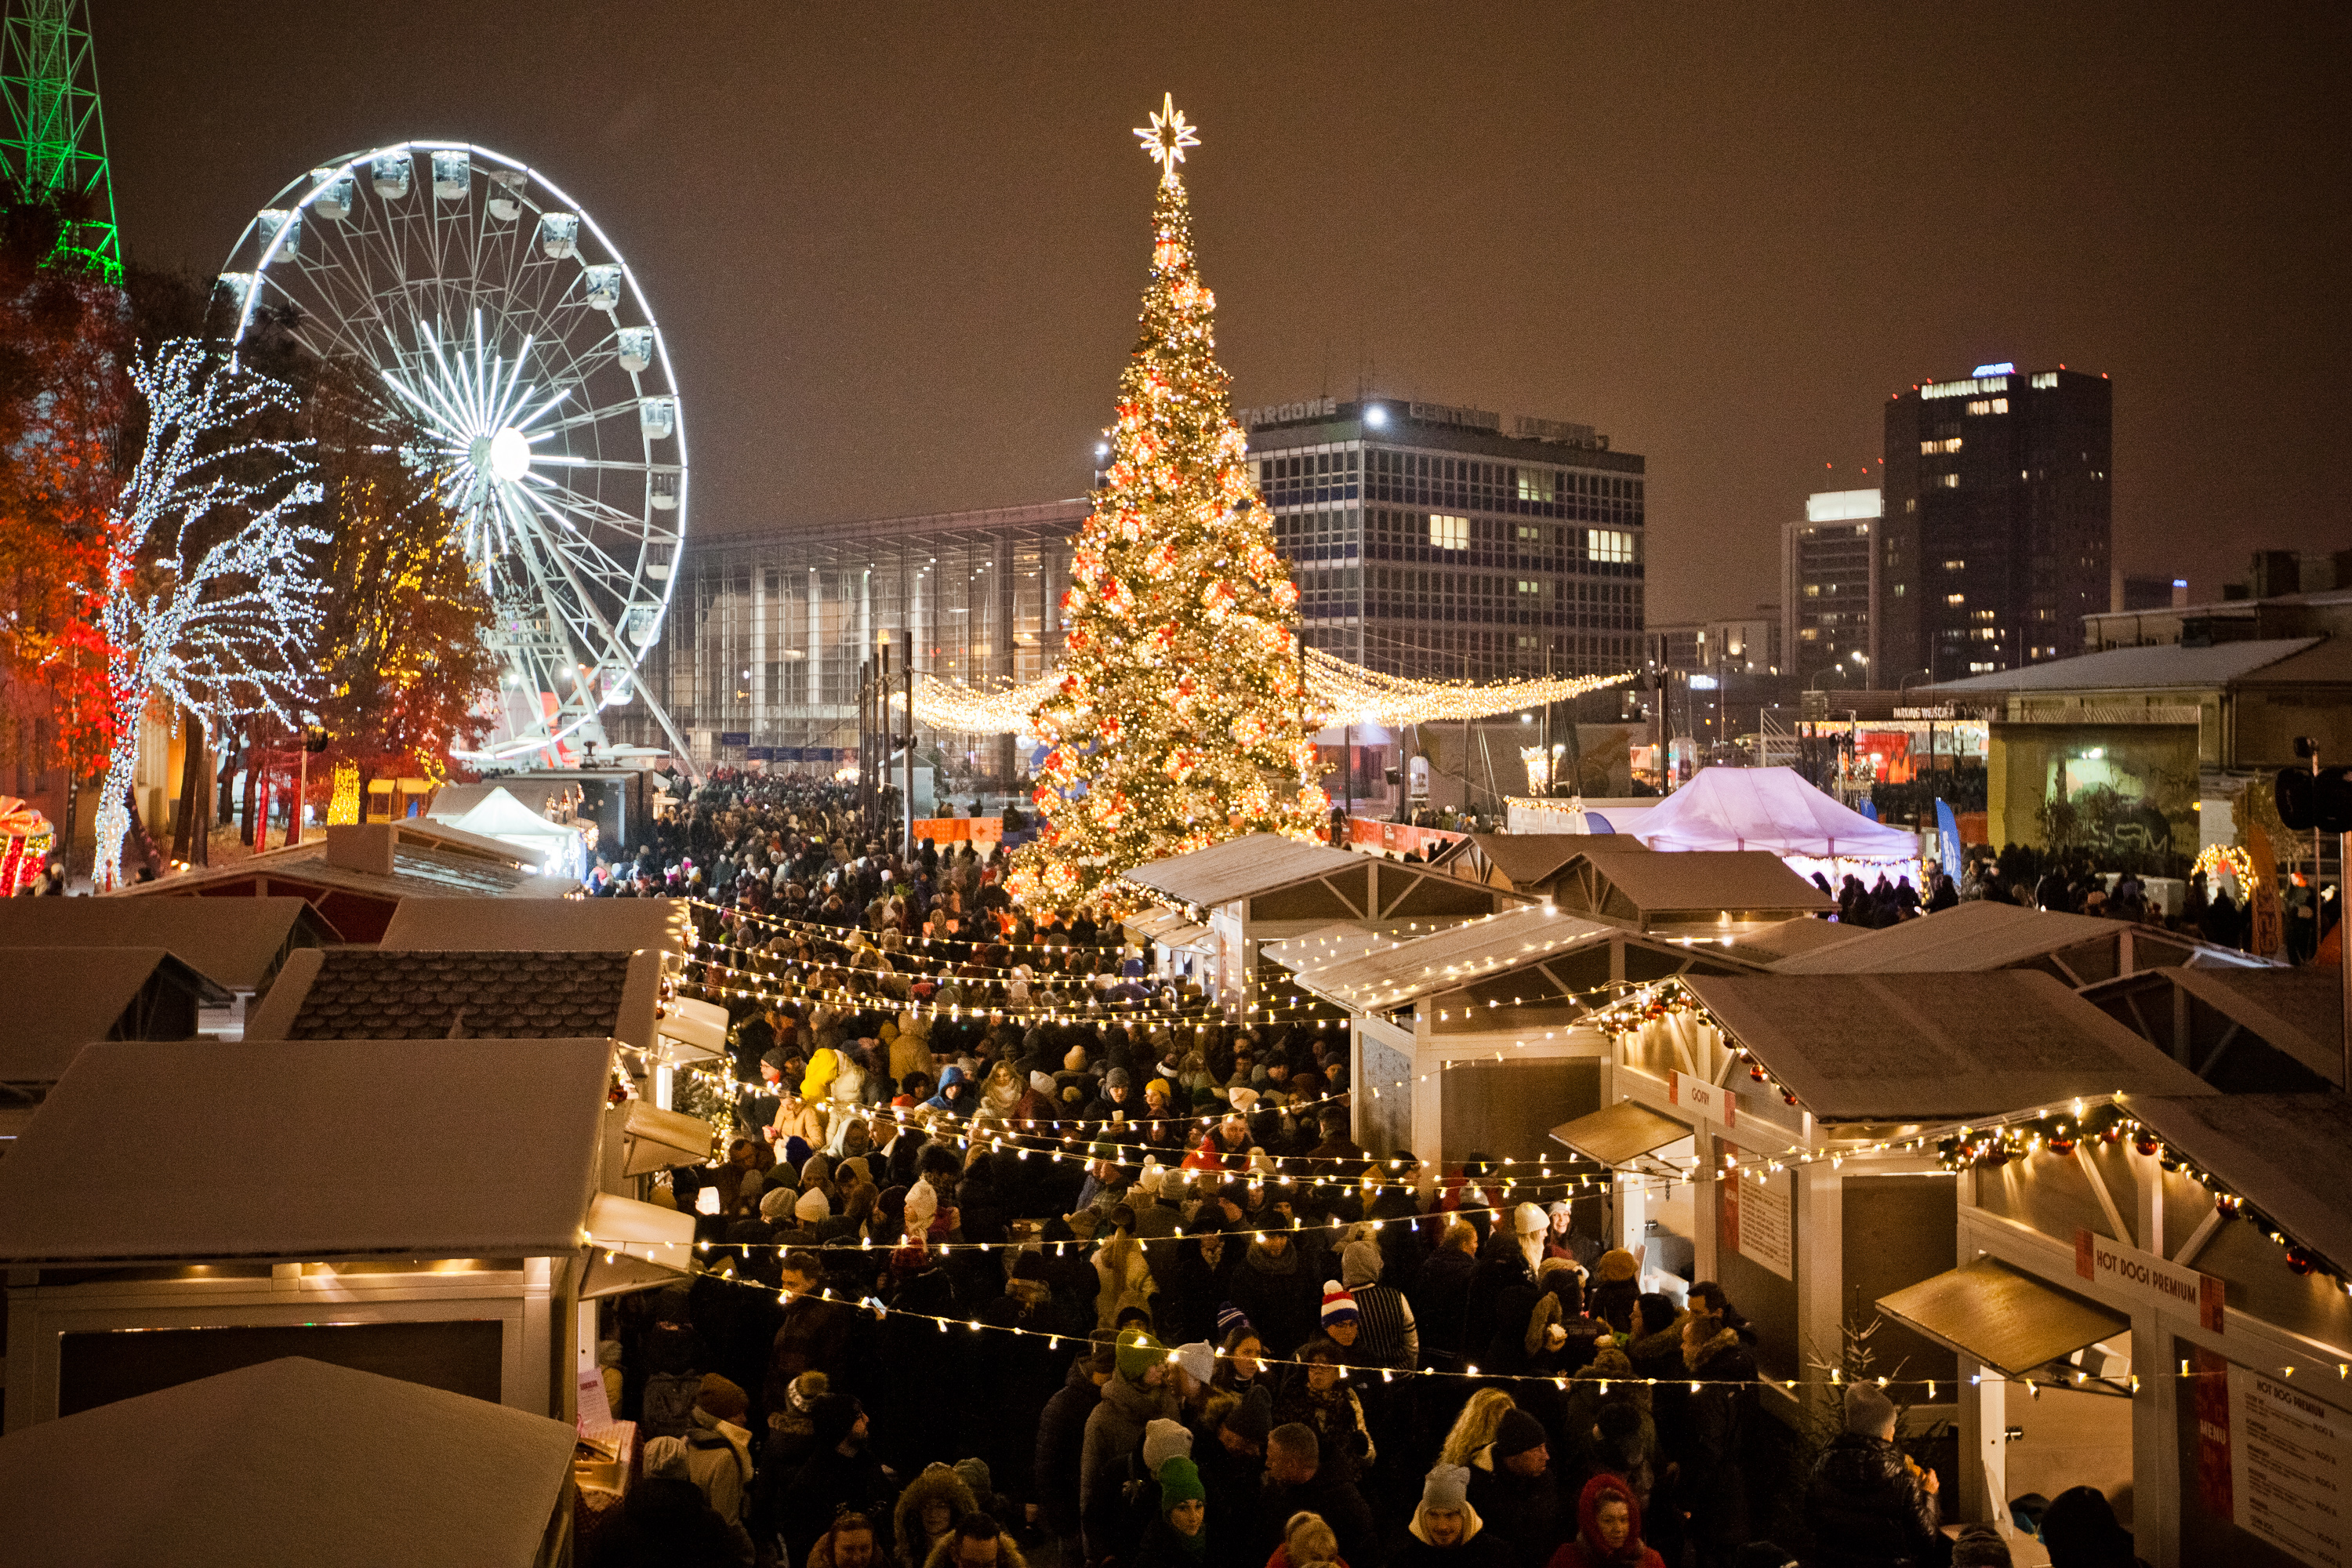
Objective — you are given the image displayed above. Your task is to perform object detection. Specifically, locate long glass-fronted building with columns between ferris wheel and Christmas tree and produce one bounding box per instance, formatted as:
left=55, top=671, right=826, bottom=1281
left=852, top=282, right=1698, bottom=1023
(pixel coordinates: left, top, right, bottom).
left=609, top=499, right=1091, bottom=774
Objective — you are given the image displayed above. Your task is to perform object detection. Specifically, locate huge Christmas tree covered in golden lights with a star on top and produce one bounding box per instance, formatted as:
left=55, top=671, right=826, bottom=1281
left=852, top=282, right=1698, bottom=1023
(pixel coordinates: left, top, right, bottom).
left=1014, top=101, right=1331, bottom=898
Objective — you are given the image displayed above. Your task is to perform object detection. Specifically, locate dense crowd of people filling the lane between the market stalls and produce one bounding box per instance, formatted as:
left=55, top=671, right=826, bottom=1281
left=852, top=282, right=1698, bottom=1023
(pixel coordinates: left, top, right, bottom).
left=581, top=779, right=2131, bottom=1568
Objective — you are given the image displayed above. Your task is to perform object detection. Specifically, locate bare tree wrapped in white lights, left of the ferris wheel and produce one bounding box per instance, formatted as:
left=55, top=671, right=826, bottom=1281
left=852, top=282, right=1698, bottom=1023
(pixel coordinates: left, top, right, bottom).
left=92, top=339, right=327, bottom=886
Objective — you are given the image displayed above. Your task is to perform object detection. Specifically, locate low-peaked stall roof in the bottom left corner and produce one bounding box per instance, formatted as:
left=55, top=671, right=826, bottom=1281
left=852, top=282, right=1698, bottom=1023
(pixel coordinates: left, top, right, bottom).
left=0, top=1356, right=579, bottom=1568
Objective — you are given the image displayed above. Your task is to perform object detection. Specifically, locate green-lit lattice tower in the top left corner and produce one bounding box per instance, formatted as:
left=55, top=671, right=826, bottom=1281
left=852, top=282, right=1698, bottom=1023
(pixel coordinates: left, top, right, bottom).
left=0, top=0, right=122, bottom=278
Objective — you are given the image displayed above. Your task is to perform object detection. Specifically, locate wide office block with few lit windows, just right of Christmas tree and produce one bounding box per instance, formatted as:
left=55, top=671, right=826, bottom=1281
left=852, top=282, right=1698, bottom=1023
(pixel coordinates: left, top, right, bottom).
left=1240, top=397, right=1646, bottom=680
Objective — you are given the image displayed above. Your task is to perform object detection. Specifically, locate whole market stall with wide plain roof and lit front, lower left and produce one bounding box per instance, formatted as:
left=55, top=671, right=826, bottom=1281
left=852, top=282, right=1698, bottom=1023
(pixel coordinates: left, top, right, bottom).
left=0, top=1039, right=694, bottom=1432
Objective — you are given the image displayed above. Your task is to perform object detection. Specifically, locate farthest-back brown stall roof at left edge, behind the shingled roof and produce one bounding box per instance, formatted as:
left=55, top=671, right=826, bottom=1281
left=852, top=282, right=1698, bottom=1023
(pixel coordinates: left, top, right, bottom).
left=0, top=898, right=336, bottom=992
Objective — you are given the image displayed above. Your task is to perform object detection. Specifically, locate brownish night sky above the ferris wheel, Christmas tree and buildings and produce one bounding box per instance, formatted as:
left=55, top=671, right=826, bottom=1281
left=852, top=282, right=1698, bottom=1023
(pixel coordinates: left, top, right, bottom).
left=92, top=0, right=2352, bottom=621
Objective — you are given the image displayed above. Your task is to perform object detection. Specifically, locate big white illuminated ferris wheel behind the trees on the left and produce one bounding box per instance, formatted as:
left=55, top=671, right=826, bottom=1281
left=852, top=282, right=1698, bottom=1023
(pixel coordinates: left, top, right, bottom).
left=221, top=141, right=691, bottom=767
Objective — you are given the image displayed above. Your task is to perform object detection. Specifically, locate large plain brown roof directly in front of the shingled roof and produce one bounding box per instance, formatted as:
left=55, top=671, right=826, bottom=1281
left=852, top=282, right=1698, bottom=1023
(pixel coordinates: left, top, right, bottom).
left=0, top=1039, right=612, bottom=1265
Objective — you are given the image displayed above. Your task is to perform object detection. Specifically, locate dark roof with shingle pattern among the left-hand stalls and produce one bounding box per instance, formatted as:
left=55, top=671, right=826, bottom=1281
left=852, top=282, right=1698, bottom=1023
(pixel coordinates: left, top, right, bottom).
left=245, top=947, right=652, bottom=1044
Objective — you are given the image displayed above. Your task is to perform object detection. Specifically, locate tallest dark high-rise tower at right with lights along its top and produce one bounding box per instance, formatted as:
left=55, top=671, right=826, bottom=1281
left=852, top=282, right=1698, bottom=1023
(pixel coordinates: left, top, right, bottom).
left=1870, top=362, right=2114, bottom=687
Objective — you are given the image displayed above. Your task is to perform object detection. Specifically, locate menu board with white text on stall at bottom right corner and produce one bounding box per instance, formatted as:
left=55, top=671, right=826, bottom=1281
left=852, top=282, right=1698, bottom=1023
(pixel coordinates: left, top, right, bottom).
left=2230, top=1366, right=2352, bottom=1568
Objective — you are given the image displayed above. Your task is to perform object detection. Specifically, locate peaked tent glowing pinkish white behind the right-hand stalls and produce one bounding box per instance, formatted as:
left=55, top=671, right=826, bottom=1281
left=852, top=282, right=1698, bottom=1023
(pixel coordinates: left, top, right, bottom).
left=1628, top=769, right=1919, bottom=884
